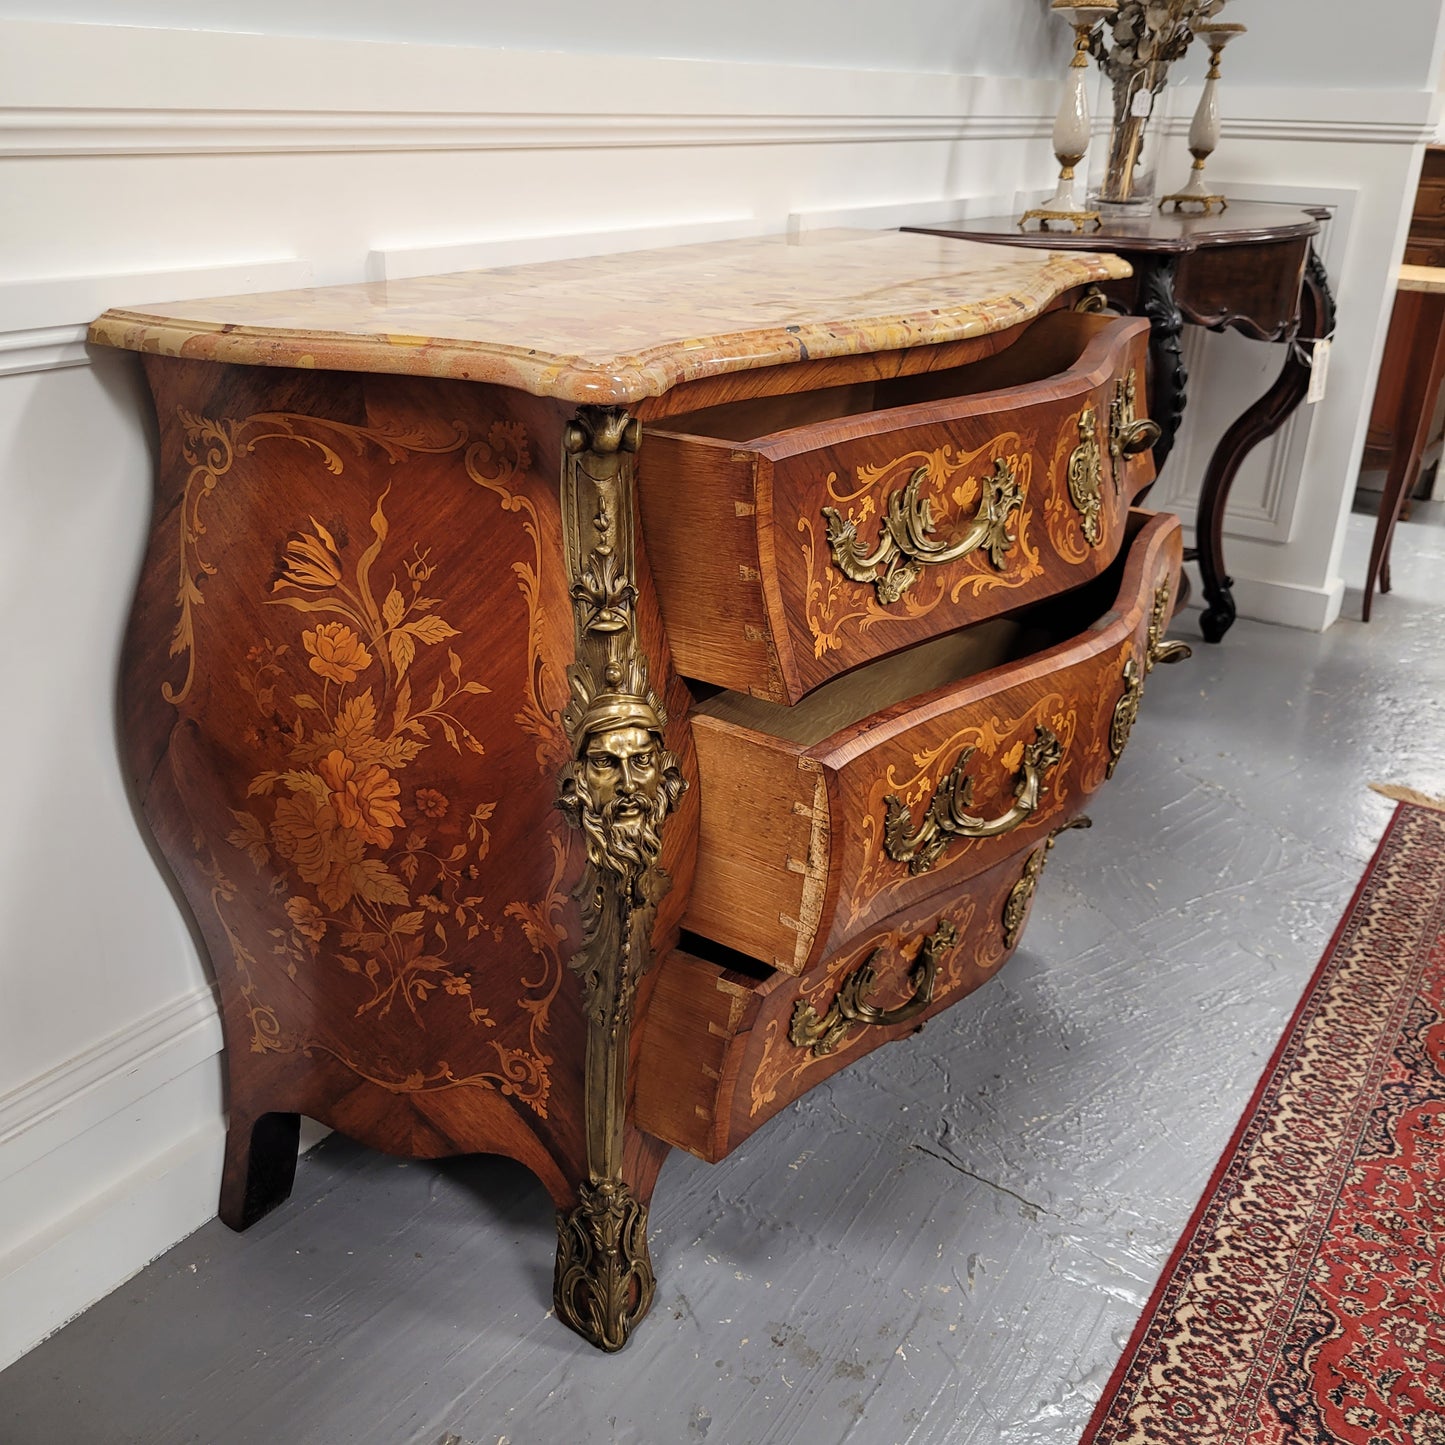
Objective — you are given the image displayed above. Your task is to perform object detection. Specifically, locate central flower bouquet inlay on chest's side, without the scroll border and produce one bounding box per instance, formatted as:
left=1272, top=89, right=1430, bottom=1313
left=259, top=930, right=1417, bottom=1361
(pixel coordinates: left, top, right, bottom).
left=227, top=493, right=500, bottom=1027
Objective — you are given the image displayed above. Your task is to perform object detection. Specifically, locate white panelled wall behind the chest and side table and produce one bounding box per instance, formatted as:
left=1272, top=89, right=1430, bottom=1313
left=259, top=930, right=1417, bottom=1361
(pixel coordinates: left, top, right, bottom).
left=0, top=0, right=1435, bottom=1363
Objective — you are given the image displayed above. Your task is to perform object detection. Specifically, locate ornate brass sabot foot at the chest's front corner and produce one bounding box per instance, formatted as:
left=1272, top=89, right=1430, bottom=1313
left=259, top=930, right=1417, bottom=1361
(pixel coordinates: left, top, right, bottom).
left=552, top=1181, right=657, bottom=1353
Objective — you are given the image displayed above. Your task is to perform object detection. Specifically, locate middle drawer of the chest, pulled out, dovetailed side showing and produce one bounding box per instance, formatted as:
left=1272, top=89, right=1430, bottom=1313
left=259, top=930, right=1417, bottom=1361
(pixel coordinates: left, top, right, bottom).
left=683, top=502, right=1181, bottom=974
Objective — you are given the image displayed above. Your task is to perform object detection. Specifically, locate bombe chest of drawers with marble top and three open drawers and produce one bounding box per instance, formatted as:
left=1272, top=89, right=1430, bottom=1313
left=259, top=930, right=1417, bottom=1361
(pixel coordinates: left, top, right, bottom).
left=91, top=233, right=1182, bottom=1350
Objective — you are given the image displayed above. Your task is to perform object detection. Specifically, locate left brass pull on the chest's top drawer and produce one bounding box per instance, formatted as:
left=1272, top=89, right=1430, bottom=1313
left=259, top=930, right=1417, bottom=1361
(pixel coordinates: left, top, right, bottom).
left=822, top=457, right=1025, bottom=604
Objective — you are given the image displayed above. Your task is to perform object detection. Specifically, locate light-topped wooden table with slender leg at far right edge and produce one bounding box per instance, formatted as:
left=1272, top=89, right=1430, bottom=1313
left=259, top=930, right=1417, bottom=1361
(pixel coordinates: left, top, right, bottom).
left=1360, top=266, right=1445, bottom=621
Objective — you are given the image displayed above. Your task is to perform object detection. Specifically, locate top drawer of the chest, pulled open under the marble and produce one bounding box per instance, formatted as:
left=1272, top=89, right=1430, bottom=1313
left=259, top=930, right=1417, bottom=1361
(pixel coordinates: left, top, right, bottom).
left=642, top=312, right=1153, bottom=702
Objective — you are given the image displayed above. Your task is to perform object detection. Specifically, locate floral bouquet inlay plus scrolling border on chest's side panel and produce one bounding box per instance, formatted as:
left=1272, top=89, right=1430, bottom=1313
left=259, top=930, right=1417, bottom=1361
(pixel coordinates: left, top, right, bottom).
left=171, top=412, right=568, bottom=1116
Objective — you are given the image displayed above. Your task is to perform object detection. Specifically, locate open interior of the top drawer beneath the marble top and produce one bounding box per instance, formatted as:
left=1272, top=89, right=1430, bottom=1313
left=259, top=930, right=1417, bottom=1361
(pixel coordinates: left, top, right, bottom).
left=662, top=311, right=1118, bottom=442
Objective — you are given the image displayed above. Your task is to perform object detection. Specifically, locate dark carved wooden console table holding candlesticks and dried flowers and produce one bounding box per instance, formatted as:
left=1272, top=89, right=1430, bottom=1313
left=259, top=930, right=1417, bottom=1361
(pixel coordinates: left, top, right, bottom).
left=916, top=202, right=1335, bottom=642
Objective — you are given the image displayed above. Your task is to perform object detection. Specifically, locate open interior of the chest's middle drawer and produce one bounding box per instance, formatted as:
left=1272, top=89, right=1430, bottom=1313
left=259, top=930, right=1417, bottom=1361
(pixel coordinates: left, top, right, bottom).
left=694, top=510, right=1152, bottom=749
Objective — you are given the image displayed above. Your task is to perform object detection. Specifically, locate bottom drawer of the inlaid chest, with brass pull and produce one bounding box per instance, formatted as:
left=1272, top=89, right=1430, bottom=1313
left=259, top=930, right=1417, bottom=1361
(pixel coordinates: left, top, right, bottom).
left=636, top=826, right=1087, bottom=1160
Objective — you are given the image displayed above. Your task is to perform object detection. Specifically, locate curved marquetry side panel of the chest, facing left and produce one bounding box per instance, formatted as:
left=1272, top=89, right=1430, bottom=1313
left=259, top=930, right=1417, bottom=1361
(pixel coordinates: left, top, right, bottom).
left=123, top=358, right=695, bottom=1202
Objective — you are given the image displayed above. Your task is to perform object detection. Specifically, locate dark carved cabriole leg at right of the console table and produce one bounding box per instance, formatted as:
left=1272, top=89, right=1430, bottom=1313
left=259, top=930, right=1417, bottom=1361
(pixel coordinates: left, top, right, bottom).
left=1185, top=249, right=1335, bottom=642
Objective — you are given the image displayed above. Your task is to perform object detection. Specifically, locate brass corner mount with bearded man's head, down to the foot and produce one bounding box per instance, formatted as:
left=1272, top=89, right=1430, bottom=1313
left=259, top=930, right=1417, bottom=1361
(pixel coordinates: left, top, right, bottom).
left=553, top=406, right=686, bottom=1351
